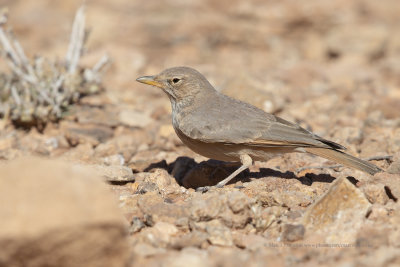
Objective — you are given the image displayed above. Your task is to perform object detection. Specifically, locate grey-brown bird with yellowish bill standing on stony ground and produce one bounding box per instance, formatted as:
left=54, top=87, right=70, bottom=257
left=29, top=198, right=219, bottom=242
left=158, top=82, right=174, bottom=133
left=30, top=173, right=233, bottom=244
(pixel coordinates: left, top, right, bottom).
left=136, top=67, right=382, bottom=192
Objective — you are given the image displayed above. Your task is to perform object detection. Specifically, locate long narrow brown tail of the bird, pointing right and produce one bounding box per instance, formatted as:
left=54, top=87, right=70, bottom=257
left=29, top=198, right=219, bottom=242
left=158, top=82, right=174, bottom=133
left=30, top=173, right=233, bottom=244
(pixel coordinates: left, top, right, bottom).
left=304, top=147, right=382, bottom=175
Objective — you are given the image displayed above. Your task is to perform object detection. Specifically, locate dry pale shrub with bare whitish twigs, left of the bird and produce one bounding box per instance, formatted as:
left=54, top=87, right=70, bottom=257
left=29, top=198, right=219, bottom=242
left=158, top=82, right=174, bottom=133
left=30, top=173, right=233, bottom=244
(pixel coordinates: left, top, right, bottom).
left=0, top=7, right=108, bottom=127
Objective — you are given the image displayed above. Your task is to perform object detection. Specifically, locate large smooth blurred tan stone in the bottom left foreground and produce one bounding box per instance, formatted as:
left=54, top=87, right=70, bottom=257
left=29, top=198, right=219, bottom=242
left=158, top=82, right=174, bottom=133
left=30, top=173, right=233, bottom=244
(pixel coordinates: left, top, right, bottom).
left=0, top=158, right=129, bottom=266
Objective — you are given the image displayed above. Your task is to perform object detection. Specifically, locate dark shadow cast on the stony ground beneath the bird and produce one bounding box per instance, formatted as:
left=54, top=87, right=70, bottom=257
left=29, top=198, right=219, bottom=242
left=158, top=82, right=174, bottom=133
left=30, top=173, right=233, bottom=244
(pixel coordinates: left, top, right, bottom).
left=144, top=157, right=336, bottom=188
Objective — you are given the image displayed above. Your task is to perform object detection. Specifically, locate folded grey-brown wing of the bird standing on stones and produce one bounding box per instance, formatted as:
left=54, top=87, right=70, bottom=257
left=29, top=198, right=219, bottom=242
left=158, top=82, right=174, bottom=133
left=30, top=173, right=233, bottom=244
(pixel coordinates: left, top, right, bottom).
left=181, top=109, right=345, bottom=149
